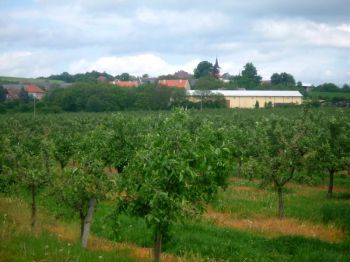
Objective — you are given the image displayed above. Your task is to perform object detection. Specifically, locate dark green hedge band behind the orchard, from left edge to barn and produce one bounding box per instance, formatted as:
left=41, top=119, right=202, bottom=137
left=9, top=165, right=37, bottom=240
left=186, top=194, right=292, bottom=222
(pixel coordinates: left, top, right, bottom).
left=0, top=82, right=226, bottom=113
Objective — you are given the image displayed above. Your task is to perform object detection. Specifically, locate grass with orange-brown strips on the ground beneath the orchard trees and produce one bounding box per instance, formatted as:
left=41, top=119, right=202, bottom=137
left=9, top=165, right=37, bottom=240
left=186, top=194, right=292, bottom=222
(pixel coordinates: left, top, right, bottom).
left=0, top=173, right=350, bottom=261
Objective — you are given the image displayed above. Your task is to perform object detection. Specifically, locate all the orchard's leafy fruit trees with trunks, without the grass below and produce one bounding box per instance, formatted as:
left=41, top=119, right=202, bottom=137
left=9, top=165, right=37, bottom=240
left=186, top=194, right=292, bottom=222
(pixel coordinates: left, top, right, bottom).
left=0, top=109, right=350, bottom=261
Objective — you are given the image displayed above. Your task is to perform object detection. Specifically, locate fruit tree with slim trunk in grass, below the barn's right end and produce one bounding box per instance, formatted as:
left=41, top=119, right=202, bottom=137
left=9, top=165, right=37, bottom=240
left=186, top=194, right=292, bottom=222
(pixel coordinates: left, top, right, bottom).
left=252, top=116, right=309, bottom=219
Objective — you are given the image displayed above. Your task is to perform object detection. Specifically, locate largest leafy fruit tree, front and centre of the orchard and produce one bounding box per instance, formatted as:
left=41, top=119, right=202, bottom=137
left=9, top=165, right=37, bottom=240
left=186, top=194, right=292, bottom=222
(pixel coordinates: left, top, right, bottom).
left=117, top=110, right=228, bottom=261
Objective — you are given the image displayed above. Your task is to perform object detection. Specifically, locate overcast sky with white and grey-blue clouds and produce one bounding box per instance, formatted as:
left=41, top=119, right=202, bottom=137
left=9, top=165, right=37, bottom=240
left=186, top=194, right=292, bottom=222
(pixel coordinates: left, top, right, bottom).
left=0, top=0, right=350, bottom=84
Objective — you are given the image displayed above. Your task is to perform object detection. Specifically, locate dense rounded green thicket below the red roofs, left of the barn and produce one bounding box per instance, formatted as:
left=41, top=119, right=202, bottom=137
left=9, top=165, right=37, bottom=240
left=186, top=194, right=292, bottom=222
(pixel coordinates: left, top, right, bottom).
left=44, top=83, right=185, bottom=112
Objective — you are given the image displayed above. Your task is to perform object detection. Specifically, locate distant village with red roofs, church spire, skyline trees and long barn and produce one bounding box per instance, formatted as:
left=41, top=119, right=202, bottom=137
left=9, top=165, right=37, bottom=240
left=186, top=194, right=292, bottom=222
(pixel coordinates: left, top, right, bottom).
left=2, top=59, right=350, bottom=111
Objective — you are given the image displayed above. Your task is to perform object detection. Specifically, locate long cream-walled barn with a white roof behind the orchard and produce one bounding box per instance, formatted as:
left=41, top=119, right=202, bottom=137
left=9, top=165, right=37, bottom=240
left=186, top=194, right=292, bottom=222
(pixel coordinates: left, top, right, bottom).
left=187, top=90, right=303, bottom=108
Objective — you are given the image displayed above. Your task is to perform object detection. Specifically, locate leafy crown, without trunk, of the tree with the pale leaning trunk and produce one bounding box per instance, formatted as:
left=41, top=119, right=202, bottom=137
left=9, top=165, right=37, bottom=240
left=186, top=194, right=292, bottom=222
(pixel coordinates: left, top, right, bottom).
left=54, top=127, right=113, bottom=214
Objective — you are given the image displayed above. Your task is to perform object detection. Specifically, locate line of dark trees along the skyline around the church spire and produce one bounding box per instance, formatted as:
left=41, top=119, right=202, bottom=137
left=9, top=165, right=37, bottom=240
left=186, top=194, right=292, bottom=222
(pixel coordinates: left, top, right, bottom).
left=32, top=61, right=350, bottom=92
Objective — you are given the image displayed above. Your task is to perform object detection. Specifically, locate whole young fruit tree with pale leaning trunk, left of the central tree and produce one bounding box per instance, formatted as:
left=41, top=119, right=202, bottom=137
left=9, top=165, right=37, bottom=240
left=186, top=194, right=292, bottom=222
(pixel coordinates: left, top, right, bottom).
left=54, top=127, right=114, bottom=248
